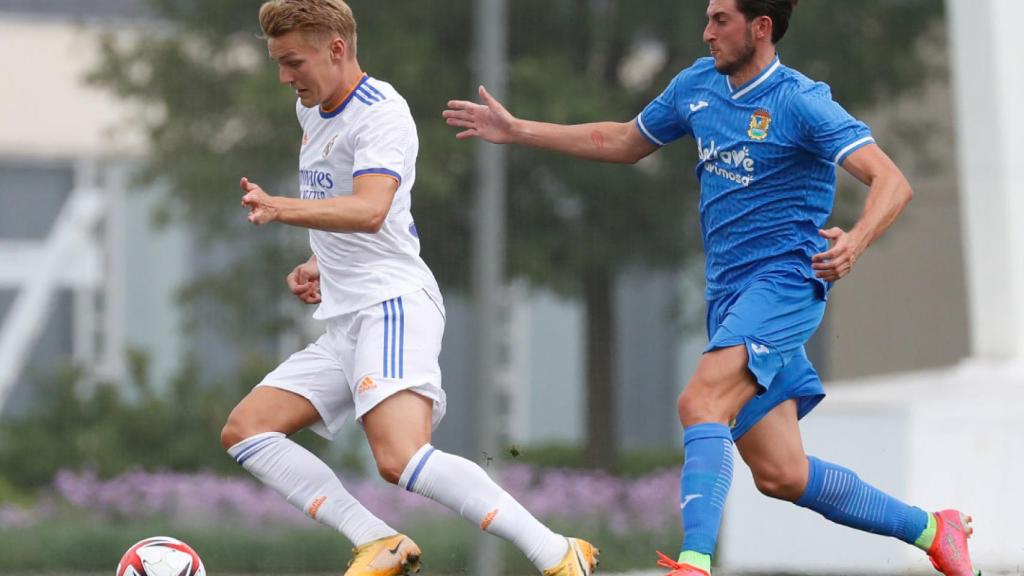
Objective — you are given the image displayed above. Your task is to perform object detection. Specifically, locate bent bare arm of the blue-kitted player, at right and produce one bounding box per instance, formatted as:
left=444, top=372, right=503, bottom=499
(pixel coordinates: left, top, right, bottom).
left=811, top=143, right=913, bottom=282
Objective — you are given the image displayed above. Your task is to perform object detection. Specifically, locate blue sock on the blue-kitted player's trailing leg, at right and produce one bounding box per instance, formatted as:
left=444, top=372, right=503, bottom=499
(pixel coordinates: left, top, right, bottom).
left=796, top=456, right=928, bottom=544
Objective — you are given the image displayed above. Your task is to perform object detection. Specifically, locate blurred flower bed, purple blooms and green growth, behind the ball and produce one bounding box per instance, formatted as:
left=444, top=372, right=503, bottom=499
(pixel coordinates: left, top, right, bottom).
left=0, top=464, right=681, bottom=574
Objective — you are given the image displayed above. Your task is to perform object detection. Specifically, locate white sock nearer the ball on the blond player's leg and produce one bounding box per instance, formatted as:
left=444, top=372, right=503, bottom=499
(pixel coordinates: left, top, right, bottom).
left=227, top=433, right=397, bottom=546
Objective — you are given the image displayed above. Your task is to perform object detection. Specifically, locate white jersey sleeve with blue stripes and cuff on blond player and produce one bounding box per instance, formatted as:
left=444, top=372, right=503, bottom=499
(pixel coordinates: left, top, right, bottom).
left=352, top=102, right=417, bottom=184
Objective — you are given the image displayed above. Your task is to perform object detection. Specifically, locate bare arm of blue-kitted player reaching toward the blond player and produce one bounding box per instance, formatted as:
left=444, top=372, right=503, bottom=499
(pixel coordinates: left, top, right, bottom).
left=442, top=86, right=657, bottom=164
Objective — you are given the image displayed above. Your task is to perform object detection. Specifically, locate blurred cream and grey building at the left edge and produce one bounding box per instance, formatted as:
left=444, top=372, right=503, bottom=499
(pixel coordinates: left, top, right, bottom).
left=0, top=0, right=188, bottom=410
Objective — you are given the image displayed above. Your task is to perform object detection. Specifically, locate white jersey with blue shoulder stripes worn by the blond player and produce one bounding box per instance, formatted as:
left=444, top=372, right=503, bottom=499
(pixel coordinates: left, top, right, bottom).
left=296, top=76, right=443, bottom=320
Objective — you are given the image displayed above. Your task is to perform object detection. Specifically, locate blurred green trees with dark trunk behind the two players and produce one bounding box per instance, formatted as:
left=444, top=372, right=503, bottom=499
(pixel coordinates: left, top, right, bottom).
left=94, top=0, right=942, bottom=467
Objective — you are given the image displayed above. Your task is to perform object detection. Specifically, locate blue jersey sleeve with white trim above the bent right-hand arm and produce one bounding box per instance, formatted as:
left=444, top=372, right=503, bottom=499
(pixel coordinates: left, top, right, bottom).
left=793, top=82, right=874, bottom=164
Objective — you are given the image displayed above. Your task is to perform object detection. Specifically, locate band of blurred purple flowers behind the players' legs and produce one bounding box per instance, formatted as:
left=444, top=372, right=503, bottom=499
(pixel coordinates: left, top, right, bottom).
left=41, top=464, right=679, bottom=534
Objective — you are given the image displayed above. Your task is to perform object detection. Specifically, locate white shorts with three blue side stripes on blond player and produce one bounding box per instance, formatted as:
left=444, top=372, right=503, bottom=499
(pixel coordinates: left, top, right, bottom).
left=257, top=290, right=445, bottom=439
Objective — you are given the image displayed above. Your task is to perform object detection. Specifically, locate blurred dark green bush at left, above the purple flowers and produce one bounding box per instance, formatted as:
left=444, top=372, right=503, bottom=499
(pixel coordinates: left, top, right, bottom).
left=0, top=351, right=339, bottom=487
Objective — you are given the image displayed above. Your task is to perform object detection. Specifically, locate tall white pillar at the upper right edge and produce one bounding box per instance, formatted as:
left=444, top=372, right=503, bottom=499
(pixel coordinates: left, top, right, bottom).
left=947, top=0, right=1024, bottom=359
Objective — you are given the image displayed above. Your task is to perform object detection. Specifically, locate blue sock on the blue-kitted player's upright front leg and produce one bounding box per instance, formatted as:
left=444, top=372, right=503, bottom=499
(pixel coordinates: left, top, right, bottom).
left=679, top=423, right=732, bottom=556
